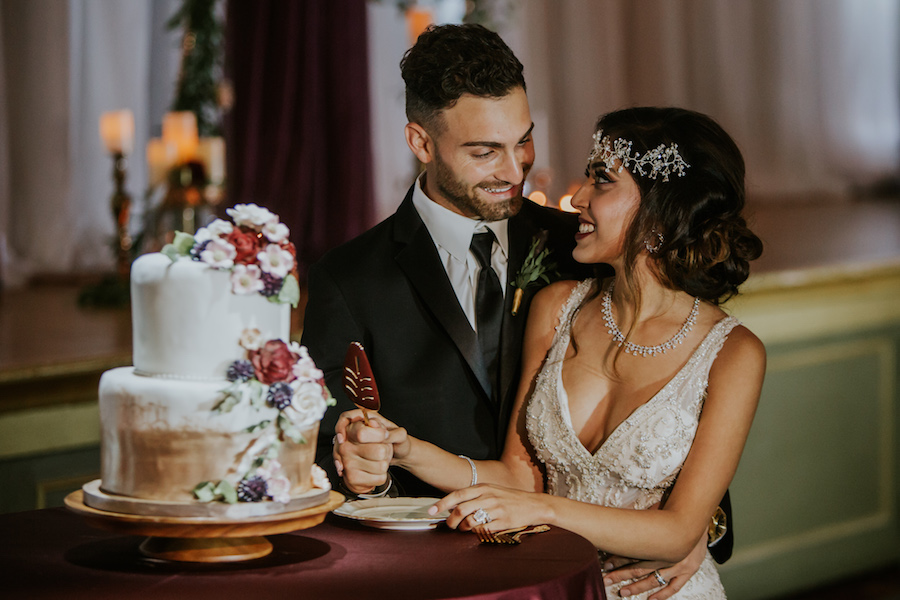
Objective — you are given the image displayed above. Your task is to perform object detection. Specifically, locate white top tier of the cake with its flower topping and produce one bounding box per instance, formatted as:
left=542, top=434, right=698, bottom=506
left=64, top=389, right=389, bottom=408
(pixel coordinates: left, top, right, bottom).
left=131, top=204, right=300, bottom=380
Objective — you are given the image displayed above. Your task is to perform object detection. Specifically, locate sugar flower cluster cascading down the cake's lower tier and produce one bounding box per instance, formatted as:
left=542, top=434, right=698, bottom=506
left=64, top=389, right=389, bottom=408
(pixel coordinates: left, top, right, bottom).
left=194, top=330, right=335, bottom=503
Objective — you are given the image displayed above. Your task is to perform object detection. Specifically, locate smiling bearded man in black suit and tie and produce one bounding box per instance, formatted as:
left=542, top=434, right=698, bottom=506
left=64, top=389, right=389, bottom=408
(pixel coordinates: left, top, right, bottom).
left=302, top=25, right=732, bottom=592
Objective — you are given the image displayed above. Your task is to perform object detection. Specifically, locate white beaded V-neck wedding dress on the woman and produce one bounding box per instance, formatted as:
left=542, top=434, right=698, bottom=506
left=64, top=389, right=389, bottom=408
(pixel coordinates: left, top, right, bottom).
left=526, top=280, right=739, bottom=600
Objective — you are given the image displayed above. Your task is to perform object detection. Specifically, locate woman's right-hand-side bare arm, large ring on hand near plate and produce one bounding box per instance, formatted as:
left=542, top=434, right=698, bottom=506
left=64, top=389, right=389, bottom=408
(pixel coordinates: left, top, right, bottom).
left=436, top=327, right=765, bottom=562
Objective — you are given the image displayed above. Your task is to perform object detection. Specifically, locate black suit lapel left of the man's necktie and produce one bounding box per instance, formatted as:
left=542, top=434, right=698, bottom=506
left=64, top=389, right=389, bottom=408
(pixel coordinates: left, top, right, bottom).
left=394, top=190, right=489, bottom=398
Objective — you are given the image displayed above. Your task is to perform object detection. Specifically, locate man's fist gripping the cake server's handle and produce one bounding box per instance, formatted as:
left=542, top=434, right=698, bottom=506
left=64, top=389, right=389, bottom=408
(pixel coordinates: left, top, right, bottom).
left=332, top=410, right=394, bottom=494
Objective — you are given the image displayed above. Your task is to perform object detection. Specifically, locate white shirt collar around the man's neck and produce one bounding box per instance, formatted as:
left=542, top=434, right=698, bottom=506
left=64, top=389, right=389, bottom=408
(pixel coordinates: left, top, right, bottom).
left=412, top=173, right=509, bottom=262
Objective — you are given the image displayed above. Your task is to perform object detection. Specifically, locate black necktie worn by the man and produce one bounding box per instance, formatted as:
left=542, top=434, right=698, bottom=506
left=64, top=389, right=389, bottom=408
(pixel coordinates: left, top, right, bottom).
left=469, top=230, right=503, bottom=400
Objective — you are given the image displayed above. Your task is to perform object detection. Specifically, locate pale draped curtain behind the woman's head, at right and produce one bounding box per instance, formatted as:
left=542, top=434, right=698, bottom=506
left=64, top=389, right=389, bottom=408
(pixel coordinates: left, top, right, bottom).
left=514, top=0, right=900, bottom=199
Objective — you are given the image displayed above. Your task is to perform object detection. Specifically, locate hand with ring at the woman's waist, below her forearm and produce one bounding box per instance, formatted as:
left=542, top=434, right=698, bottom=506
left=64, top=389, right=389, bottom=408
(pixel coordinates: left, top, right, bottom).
left=603, top=533, right=706, bottom=600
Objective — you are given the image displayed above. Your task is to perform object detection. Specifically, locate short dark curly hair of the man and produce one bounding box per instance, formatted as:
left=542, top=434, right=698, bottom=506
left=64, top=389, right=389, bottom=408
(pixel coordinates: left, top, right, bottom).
left=400, top=23, right=525, bottom=133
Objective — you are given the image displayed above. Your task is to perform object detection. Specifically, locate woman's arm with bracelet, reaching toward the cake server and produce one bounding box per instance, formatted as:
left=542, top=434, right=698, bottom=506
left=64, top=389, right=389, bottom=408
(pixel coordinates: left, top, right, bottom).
left=362, top=281, right=576, bottom=492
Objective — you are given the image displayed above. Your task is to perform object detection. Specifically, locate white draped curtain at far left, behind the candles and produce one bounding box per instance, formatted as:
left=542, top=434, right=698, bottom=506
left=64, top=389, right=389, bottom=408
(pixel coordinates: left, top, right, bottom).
left=0, top=0, right=180, bottom=286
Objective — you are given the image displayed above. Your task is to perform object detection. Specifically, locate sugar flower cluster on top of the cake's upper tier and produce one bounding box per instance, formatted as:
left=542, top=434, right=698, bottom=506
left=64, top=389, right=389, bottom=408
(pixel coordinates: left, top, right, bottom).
left=162, top=204, right=300, bottom=308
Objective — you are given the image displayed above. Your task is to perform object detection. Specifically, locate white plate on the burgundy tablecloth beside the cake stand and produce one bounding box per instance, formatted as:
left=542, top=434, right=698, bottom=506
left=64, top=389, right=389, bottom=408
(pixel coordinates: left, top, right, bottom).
left=334, top=498, right=450, bottom=531
